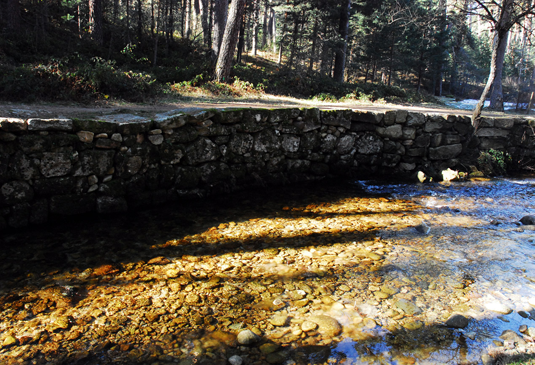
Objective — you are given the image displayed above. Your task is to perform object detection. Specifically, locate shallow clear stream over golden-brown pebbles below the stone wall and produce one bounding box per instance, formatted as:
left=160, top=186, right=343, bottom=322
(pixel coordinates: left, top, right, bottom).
left=0, top=181, right=535, bottom=365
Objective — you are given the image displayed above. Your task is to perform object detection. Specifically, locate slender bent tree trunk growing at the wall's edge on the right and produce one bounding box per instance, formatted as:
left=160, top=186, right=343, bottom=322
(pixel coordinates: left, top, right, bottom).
left=472, top=0, right=514, bottom=129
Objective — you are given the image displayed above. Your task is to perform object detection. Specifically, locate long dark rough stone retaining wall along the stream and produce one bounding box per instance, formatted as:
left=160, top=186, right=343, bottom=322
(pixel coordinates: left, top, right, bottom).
left=0, top=108, right=535, bottom=229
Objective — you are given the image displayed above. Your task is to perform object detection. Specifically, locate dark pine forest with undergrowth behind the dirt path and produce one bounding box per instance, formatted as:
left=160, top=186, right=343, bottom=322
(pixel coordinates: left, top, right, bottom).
left=0, top=0, right=534, bottom=102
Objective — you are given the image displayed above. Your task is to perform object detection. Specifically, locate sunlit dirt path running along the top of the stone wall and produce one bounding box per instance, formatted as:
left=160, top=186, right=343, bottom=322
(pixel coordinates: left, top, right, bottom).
left=0, top=94, right=525, bottom=118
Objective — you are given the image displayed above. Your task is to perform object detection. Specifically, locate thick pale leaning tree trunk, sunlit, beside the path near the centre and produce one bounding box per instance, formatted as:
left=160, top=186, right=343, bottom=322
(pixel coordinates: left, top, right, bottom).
left=215, top=0, right=245, bottom=82
